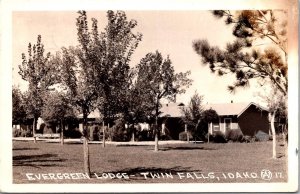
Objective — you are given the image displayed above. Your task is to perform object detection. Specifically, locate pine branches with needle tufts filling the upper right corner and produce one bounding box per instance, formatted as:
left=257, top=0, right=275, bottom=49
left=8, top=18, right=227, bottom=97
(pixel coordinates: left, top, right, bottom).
left=193, top=10, right=288, bottom=158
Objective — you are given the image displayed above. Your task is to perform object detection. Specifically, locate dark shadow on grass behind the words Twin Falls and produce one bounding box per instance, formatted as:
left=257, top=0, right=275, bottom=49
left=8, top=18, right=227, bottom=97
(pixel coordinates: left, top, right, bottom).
left=91, top=166, right=195, bottom=181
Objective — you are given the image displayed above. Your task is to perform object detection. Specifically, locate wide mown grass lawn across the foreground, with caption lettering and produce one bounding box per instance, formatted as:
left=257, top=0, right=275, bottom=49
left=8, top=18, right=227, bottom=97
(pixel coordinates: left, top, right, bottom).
left=13, top=141, right=287, bottom=183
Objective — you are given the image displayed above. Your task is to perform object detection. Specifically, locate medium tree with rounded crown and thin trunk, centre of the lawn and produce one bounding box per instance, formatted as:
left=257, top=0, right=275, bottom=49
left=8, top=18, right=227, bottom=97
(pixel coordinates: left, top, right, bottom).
left=137, top=51, right=192, bottom=151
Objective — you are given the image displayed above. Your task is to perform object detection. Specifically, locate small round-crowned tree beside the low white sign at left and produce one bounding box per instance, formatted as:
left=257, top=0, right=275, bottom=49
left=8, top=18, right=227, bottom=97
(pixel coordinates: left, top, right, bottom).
left=41, top=91, right=76, bottom=145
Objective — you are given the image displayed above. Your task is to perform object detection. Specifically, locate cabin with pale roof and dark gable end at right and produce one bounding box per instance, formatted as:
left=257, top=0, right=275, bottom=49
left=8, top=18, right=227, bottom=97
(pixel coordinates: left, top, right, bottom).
left=205, top=102, right=269, bottom=136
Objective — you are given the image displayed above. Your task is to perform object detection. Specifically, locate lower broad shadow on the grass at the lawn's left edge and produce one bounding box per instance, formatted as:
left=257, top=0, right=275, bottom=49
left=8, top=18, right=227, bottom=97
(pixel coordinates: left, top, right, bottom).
left=13, top=154, right=66, bottom=168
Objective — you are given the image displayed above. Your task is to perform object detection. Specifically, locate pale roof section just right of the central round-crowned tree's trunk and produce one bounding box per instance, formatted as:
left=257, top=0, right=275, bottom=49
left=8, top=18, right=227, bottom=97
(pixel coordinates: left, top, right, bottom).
left=160, top=103, right=184, bottom=117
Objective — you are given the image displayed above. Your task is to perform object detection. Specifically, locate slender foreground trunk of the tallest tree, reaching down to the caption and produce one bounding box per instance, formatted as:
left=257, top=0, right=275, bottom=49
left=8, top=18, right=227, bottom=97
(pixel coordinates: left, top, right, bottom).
left=83, top=109, right=91, bottom=175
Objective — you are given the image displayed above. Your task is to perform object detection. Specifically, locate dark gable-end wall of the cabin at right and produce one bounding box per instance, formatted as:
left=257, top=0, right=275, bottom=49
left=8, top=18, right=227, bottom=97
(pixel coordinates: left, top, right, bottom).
left=238, top=105, right=269, bottom=136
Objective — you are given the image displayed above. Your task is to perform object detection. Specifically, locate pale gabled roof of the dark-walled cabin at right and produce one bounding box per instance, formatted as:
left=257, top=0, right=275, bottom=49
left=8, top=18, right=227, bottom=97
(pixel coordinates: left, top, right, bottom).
left=204, top=102, right=268, bottom=117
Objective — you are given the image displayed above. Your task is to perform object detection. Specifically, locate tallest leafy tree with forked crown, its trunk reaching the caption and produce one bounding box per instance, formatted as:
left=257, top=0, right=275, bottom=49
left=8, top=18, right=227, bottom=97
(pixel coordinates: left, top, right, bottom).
left=60, top=11, right=141, bottom=173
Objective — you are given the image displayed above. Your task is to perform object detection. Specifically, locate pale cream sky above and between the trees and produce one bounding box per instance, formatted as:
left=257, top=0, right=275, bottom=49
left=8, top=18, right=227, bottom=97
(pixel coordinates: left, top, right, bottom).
left=12, top=10, right=272, bottom=103
